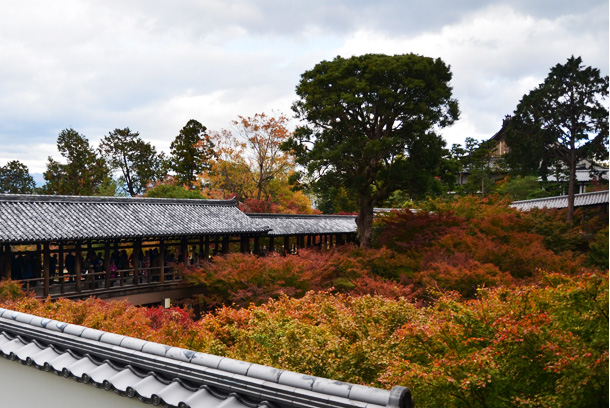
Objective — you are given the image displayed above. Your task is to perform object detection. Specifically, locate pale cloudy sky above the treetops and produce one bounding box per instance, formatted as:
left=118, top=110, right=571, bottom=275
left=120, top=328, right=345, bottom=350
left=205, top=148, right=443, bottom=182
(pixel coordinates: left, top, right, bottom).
left=0, top=0, right=609, bottom=173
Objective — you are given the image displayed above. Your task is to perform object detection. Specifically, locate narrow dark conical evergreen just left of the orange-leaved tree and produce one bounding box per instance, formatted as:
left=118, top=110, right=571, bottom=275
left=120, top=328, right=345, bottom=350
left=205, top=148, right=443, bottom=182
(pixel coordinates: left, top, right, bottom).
left=169, top=119, right=215, bottom=189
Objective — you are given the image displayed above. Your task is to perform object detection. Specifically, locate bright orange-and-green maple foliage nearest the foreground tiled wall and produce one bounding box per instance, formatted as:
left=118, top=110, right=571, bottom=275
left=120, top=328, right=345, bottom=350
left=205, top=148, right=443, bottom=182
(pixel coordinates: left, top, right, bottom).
left=4, top=273, right=608, bottom=407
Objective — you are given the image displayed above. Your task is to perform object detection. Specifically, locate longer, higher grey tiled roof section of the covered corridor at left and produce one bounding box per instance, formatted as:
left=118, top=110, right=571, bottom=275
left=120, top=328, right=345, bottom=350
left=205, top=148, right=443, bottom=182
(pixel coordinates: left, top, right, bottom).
left=0, top=194, right=268, bottom=243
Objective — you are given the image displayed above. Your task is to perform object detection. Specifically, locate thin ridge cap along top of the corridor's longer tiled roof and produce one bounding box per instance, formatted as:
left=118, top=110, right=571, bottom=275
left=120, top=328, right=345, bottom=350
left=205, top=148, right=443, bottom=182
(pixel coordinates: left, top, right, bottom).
left=0, top=194, right=237, bottom=207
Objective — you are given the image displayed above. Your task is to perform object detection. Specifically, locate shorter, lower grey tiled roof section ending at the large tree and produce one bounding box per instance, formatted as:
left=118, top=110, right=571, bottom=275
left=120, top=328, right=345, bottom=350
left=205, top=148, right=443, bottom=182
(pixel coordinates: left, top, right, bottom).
left=248, top=214, right=356, bottom=236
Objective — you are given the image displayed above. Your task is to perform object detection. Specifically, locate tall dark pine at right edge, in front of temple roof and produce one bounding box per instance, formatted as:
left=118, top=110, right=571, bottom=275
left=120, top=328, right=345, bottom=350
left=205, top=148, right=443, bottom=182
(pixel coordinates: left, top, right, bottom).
left=506, top=56, right=608, bottom=221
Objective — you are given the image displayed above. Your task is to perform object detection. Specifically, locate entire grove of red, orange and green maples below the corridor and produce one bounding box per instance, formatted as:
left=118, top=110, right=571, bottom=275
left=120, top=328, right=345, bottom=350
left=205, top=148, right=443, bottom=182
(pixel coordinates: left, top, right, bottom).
left=0, top=196, right=608, bottom=407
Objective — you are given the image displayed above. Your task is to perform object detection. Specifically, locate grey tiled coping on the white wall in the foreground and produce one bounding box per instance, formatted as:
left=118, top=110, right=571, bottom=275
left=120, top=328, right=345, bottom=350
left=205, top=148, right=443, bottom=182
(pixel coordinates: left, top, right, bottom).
left=0, top=308, right=412, bottom=408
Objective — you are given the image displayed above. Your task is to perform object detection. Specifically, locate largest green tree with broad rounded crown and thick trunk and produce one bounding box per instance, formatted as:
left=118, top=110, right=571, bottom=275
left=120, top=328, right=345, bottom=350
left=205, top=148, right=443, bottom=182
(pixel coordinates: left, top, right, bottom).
left=284, top=54, right=459, bottom=246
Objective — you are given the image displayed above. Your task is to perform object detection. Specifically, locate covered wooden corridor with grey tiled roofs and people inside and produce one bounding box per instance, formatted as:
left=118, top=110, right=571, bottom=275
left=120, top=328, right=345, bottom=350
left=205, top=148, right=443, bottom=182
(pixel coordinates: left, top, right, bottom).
left=0, top=195, right=356, bottom=303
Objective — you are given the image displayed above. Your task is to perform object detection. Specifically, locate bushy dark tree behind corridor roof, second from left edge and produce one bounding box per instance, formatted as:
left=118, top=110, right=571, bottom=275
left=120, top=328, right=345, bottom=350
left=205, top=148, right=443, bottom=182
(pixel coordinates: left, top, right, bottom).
left=44, top=129, right=111, bottom=196
